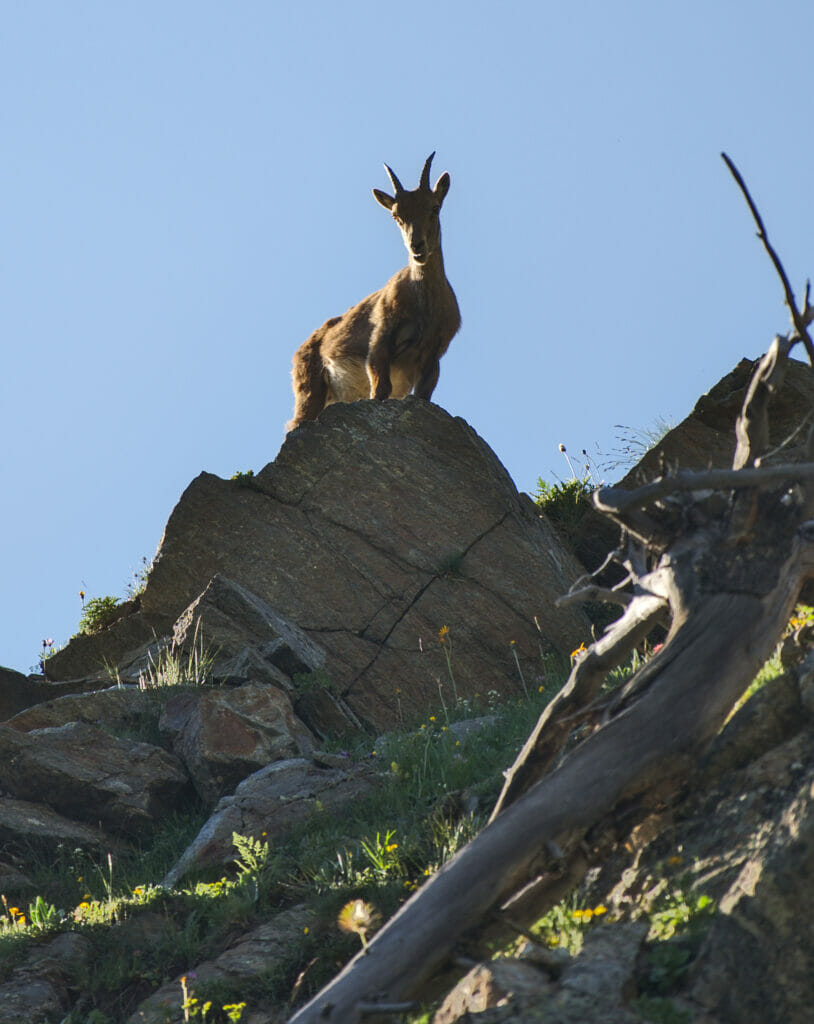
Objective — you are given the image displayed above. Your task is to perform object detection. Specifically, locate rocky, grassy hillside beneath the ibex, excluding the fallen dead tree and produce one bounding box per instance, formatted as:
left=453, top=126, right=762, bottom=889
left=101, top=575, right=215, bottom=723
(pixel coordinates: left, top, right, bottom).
left=0, top=372, right=814, bottom=1024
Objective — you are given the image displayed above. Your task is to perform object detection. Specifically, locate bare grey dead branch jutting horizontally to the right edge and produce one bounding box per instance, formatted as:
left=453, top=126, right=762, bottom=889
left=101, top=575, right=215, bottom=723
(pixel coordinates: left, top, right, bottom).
left=594, top=462, right=814, bottom=515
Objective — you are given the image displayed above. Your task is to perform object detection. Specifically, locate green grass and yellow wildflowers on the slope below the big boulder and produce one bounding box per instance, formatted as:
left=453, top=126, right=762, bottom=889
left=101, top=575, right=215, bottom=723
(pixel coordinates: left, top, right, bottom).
left=0, top=610, right=794, bottom=1024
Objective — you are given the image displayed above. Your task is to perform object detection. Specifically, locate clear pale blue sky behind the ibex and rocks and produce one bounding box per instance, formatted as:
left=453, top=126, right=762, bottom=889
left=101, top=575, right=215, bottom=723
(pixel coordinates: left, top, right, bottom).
left=0, top=0, right=814, bottom=671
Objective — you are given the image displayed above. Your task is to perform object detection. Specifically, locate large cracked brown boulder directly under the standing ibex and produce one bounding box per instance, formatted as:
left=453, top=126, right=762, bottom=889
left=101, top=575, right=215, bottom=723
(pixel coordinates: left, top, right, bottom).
left=46, top=398, right=588, bottom=728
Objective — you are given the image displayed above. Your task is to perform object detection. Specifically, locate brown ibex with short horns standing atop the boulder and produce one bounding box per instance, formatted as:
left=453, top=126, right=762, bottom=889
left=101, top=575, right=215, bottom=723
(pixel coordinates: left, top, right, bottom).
left=286, top=153, right=461, bottom=430
